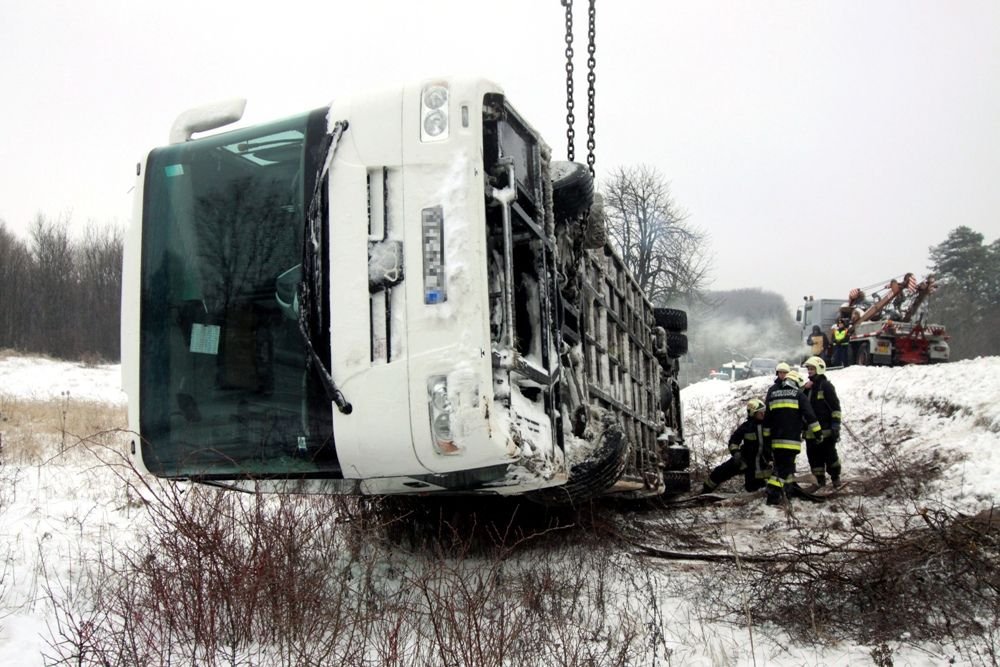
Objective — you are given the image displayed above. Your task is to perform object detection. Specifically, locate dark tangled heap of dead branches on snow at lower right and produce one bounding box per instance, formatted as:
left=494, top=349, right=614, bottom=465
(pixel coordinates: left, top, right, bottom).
left=709, top=508, right=1000, bottom=656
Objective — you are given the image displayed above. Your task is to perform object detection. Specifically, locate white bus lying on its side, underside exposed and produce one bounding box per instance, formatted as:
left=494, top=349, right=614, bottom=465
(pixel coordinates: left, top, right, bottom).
left=122, top=79, right=688, bottom=503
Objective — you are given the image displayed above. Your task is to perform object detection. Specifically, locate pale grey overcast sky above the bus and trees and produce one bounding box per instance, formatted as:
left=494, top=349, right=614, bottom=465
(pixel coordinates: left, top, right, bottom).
left=0, top=0, right=1000, bottom=308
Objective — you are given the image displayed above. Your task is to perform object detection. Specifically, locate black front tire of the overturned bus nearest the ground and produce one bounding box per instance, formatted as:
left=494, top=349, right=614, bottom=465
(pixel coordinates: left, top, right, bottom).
left=527, top=417, right=629, bottom=507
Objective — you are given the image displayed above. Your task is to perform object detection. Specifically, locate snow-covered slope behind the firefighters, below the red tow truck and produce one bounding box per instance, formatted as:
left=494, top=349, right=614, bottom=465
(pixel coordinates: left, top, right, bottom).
left=681, top=357, right=1000, bottom=512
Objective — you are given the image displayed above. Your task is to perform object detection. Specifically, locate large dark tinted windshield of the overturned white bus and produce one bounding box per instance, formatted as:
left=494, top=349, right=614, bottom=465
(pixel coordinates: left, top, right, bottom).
left=140, top=109, right=340, bottom=479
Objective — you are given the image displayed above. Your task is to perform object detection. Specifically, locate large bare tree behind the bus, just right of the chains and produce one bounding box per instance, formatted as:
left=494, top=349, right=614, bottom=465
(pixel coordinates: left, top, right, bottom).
left=604, top=165, right=709, bottom=305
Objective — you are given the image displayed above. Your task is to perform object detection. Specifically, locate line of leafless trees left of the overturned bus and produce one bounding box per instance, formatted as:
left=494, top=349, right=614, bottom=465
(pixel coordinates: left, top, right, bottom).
left=0, top=214, right=124, bottom=361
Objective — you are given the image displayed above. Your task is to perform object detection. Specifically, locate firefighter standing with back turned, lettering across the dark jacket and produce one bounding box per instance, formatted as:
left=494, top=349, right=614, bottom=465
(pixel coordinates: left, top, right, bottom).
left=764, top=371, right=823, bottom=505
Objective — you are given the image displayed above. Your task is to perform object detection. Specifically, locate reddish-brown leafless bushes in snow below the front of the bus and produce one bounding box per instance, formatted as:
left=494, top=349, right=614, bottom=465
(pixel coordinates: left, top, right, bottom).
left=37, top=449, right=656, bottom=667
